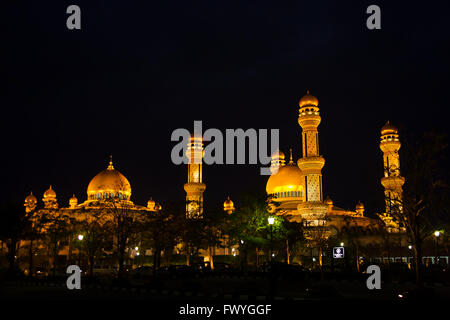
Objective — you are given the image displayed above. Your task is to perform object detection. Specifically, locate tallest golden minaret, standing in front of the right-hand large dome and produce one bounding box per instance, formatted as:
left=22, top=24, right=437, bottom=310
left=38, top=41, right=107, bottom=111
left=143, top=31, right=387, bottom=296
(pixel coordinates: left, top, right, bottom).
left=297, top=91, right=325, bottom=202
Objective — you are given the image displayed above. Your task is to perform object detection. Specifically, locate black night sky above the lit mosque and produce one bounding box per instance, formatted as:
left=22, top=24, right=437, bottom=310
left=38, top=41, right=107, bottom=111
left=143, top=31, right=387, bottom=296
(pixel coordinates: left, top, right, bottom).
left=0, top=0, right=450, bottom=218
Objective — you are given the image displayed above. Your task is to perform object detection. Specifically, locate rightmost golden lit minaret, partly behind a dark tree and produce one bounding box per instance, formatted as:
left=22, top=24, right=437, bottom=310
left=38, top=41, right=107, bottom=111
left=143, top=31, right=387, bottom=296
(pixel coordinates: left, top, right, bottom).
left=380, top=121, right=405, bottom=215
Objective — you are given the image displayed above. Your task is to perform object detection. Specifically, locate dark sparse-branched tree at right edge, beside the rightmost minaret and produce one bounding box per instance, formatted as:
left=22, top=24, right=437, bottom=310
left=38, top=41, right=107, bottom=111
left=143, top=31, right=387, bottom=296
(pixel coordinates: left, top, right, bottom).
left=388, top=133, right=449, bottom=285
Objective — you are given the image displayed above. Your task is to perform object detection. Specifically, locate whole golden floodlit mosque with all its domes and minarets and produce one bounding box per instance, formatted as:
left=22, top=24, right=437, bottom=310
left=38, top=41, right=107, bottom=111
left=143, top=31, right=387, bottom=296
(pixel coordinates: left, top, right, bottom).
left=20, top=91, right=405, bottom=268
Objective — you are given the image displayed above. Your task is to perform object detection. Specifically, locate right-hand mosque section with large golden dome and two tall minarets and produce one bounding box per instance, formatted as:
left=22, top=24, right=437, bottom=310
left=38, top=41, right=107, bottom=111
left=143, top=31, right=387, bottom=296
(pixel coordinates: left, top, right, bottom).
left=266, top=91, right=404, bottom=234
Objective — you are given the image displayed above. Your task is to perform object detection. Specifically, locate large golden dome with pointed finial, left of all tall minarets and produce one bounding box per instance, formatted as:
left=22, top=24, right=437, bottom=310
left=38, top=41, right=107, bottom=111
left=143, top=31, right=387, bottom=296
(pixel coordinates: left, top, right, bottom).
left=87, top=159, right=131, bottom=200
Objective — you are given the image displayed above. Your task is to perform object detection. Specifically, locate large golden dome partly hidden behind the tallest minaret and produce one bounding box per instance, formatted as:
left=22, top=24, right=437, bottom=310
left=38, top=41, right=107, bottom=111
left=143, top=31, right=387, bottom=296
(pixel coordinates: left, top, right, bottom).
left=266, top=162, right=303, bottom=194
